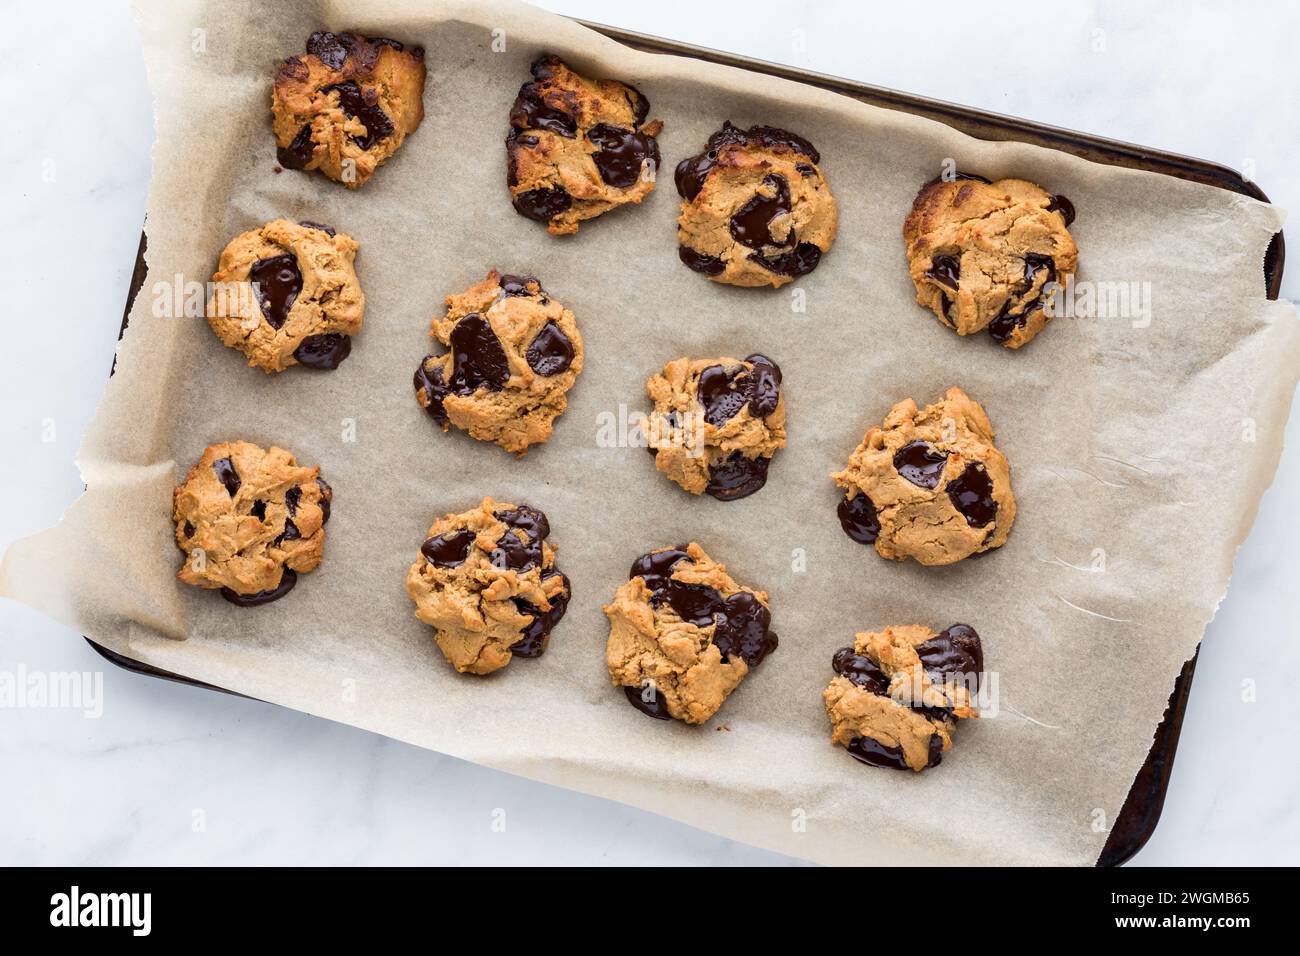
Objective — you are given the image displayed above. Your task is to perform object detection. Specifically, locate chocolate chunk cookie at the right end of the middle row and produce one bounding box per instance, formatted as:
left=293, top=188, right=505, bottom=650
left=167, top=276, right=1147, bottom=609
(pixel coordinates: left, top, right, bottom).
left=831, top=388, right=1015, bottom=564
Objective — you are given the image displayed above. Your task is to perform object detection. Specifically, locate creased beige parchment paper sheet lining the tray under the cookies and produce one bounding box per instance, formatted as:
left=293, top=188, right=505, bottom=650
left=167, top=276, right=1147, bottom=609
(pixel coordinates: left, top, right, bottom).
left=0, top=0, right=1300, bottom=864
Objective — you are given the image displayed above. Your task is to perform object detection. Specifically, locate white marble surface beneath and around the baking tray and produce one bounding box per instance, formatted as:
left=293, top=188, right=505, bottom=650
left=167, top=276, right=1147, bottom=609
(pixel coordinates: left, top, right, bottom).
left=0, top=0, right=1300, bottom=865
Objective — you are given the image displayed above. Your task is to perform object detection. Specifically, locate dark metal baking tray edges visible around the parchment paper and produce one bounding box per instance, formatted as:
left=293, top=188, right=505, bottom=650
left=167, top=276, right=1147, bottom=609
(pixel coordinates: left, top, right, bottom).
left=86, top=20, right=1286, bottom=866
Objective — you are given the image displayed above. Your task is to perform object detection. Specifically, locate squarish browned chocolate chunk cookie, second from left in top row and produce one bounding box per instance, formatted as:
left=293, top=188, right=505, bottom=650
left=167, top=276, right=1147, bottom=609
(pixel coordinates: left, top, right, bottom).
left=506, top=56, right=663, bottom=235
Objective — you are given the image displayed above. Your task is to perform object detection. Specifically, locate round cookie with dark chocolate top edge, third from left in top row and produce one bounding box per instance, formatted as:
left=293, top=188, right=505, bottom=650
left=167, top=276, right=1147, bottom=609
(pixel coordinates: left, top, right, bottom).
left=676, top=122, right=837, bottom=287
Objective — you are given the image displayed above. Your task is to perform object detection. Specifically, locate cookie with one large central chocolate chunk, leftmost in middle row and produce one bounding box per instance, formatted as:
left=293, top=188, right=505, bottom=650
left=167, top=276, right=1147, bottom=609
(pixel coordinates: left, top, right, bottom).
left=208, top=219, right=365, bottom=372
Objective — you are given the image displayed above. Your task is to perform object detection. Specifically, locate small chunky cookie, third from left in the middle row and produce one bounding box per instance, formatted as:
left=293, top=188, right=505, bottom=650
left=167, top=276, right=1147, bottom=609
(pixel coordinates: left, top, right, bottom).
left=640, top=355, right=785, bottom=501
